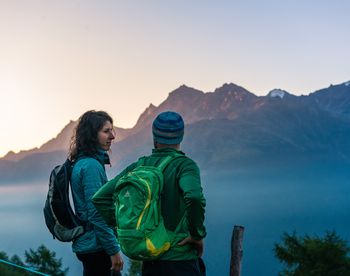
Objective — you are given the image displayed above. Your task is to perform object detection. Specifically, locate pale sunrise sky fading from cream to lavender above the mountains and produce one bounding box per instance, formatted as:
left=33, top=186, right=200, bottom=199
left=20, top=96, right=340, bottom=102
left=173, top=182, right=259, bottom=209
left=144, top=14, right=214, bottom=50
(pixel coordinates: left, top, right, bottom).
left=0, top=0, right=350, bottom=156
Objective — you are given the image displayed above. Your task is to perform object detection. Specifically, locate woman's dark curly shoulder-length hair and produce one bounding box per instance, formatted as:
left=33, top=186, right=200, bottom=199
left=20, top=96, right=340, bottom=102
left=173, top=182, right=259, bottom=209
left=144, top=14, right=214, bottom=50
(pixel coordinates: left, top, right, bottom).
left=69, top=110, right=113, bottom=161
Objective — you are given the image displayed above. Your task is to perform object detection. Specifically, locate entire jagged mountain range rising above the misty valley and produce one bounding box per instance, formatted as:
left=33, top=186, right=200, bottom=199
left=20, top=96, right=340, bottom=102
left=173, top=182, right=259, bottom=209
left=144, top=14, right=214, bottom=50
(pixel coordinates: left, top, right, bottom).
left=0, top=82, right=350, bottom=183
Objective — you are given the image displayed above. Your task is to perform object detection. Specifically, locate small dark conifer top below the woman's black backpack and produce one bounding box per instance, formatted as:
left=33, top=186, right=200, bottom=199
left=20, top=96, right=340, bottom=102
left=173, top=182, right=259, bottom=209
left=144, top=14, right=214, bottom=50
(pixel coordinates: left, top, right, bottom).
left=24, top=245, right=68, bottom=276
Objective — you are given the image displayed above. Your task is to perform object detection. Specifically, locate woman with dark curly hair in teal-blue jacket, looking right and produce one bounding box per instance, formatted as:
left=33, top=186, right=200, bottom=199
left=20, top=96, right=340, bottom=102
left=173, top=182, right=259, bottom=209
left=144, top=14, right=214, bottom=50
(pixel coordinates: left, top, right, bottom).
left=69, top=110, right=123, bottom=276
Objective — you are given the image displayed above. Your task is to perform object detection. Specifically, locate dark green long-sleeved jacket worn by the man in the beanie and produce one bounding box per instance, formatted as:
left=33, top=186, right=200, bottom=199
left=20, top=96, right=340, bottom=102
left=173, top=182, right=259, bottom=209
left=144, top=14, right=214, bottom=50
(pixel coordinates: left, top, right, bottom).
left=92, top=148, right=206, bottom=260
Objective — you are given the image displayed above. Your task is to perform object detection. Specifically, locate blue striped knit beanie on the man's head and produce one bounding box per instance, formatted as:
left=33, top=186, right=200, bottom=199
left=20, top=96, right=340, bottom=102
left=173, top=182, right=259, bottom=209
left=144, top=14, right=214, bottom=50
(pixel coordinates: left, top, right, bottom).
left=152, top=111, right=184, bottom=145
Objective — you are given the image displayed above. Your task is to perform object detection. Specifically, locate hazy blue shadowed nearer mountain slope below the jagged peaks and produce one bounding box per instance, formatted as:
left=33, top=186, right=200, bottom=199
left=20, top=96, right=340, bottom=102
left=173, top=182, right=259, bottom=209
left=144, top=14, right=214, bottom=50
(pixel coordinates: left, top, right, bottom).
left=112, top=87, right=350, bottom=175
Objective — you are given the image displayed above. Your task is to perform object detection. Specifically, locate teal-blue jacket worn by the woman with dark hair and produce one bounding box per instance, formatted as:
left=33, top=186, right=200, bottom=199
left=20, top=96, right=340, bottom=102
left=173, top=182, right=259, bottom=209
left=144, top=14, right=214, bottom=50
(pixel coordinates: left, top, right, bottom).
left=71, top=150, right=120, bottom=256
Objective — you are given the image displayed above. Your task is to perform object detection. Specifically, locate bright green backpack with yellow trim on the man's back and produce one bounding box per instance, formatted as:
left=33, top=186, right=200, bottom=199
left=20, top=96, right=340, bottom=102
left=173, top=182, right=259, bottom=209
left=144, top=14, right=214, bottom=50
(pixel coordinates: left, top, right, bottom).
left=115, top=155, right=177, bottom=260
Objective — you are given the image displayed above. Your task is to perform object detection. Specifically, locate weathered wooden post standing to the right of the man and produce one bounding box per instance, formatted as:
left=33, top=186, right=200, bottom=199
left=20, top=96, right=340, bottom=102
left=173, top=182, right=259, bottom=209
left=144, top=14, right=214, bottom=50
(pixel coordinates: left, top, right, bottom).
left=230, top=225, right=244, bottom=276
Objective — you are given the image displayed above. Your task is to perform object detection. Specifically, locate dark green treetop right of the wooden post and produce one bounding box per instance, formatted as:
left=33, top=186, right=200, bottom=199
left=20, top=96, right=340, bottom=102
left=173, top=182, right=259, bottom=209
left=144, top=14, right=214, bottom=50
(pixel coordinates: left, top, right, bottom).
left=274, top=231, right=350, bottom=276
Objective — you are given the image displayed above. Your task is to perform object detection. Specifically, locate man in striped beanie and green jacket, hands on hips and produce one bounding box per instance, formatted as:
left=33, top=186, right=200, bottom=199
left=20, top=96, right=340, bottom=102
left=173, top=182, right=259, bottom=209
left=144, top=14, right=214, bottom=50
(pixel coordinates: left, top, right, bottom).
left=93, top=111, right=206, bottom=276
